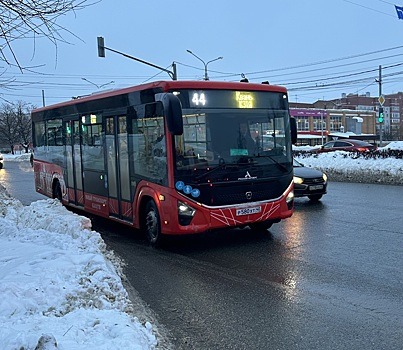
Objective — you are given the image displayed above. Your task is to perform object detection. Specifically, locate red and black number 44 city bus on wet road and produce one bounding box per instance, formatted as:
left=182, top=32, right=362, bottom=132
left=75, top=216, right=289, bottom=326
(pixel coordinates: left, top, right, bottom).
left=32, top=81, right=296, bottom=245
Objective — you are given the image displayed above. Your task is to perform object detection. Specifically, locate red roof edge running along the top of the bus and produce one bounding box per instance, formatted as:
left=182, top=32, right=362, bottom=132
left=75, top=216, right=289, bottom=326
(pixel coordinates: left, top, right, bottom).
left=32, top=80, right=287, bottom=113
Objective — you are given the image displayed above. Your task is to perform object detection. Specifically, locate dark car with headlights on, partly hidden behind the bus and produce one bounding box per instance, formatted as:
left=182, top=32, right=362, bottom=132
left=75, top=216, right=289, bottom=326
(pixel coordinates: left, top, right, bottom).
left=293, top=159, right=327, bottom=202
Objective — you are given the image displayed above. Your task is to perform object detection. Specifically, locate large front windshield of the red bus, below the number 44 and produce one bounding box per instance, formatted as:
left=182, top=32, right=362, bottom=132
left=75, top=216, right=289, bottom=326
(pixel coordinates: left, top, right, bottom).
left=175, top=109, right=292, bottom=176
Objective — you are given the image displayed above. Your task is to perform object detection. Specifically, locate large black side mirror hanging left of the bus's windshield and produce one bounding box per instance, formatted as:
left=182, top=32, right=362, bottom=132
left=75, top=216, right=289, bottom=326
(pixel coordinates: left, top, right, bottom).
left=155, top=93, right=183, bottom=135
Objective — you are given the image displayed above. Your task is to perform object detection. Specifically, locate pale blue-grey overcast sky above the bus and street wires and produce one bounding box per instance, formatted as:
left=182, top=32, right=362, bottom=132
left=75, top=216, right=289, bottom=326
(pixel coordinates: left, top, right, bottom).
left=0, top=0, right=403, bottom=106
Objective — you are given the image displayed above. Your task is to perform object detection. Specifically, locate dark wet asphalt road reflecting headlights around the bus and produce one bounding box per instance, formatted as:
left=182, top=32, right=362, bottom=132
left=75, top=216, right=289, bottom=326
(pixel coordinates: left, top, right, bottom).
left=0, top=160, right=403, bottom=350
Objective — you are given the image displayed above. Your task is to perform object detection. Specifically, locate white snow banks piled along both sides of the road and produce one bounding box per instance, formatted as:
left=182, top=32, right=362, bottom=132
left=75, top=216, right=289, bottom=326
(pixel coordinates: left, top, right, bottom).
left=0, top=142, right=403, bottom=350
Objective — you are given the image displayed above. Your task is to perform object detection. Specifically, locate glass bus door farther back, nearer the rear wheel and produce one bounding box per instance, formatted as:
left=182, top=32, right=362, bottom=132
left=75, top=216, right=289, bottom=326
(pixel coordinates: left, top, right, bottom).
left=63, top=120, right=84, bottom=206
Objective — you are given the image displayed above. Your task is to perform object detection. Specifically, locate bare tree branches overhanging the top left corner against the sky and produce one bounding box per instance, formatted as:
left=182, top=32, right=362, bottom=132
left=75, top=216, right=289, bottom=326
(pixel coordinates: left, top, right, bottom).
left=0, top=0, right=89, bottom=70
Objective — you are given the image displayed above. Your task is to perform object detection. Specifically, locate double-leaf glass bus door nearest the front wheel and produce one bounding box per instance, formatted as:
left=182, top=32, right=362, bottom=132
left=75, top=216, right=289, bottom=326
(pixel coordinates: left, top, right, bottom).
left=105, top=115, right=133, bottom=221
